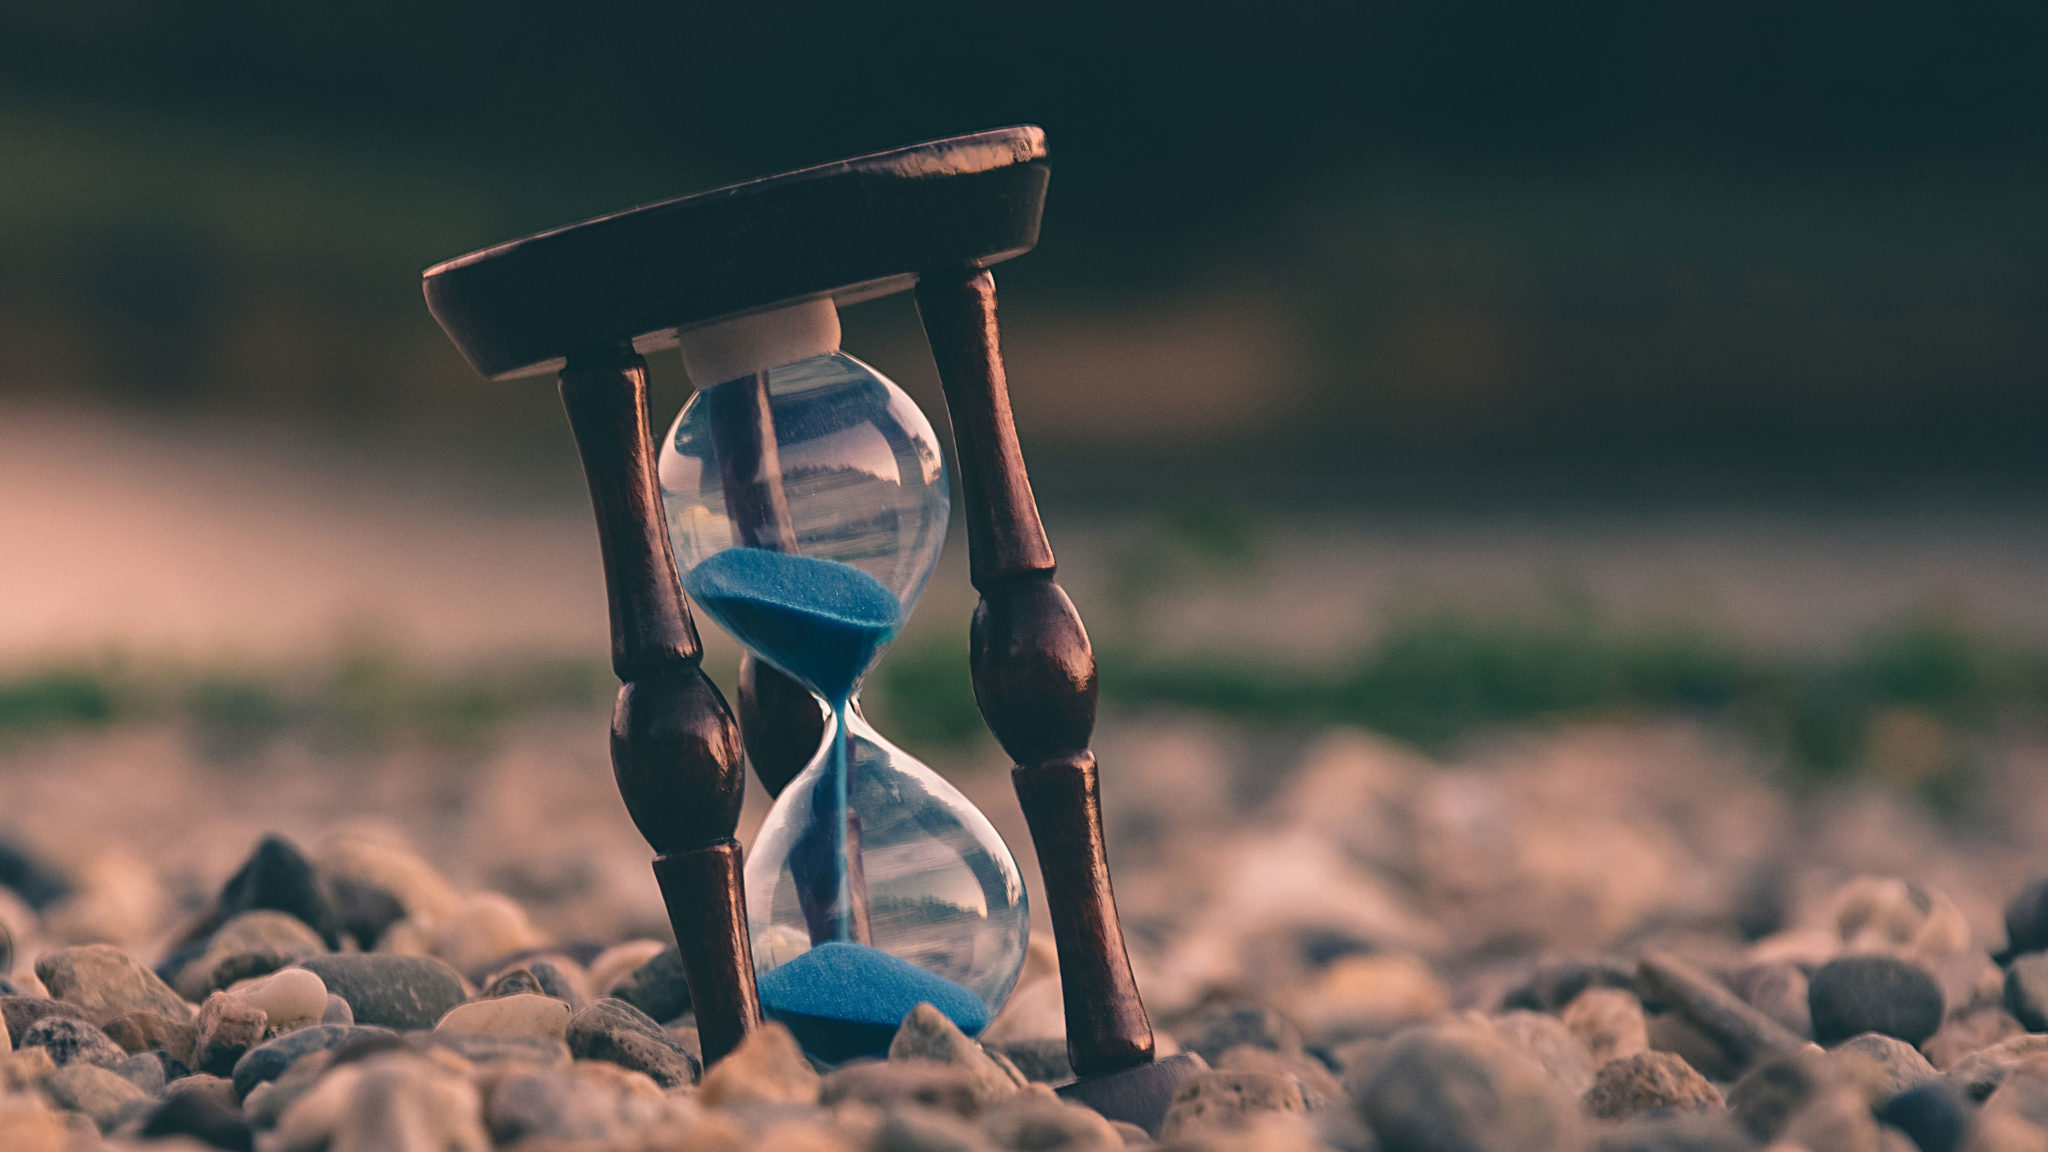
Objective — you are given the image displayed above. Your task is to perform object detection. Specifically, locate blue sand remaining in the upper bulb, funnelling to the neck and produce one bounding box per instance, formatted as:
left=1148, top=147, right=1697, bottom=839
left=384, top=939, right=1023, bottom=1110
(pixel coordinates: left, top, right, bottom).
left=682, top=547, right=903, bottom=705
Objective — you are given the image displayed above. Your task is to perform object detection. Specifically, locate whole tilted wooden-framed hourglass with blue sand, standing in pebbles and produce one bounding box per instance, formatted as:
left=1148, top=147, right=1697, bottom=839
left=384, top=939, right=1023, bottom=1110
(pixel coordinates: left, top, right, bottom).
left=426, top=127, right=1200, bottom=1129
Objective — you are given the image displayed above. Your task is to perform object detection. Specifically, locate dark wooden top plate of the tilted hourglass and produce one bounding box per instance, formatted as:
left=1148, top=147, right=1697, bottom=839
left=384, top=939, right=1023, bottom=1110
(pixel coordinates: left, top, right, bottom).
left=424, top=125, right=1051, bottom=379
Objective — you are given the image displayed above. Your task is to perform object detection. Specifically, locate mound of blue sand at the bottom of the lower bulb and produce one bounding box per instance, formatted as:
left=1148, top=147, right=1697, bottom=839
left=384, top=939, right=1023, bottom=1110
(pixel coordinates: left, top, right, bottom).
left=760, top=941, right=989, bottom=1064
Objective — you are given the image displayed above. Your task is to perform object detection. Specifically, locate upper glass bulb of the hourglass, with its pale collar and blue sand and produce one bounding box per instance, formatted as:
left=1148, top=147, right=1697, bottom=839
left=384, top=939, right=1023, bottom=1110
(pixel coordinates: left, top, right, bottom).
left=657, top=301, right=950, bottom=705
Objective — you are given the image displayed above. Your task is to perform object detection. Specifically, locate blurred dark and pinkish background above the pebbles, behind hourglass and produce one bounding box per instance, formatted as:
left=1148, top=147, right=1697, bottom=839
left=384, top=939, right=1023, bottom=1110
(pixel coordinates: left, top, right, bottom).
left=0, top=0, right=2048, bottom=983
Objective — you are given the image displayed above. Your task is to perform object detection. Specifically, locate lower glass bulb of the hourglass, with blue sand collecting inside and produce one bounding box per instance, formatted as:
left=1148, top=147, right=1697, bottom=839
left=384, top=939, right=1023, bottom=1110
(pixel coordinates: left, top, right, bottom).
left=745, top=709, right=1030, bottom=1062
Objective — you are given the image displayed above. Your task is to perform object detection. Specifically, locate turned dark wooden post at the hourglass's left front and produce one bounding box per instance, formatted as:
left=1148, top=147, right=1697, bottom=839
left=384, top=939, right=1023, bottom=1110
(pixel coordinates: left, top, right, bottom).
left=561, top=346, right=760, bottom=1062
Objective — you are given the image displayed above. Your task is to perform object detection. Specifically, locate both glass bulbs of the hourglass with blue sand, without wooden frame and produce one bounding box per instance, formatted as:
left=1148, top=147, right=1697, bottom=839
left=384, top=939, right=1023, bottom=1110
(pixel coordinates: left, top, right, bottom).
left=657, top=299, right=1030, bottom=1062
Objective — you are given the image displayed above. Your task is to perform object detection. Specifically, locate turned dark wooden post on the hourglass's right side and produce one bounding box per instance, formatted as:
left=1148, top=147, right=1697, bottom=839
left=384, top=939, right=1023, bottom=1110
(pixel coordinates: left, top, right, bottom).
left=918, top=266, right=1153, bottom=1078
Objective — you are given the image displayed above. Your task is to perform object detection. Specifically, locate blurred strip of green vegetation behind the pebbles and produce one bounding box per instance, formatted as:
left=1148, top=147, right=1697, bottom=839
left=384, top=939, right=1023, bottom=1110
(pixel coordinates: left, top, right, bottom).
left=0, top=613, right=2048, bottom=801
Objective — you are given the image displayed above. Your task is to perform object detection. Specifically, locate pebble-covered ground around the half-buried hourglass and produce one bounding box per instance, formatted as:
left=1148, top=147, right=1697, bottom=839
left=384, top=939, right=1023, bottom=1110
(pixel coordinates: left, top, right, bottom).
left=0, top=722, right=2048, bottom=1152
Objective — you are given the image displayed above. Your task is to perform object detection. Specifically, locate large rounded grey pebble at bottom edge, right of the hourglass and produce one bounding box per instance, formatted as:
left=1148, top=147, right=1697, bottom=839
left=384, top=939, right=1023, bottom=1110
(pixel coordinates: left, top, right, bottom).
left=1354, top=1025, right=1583, bottom=1152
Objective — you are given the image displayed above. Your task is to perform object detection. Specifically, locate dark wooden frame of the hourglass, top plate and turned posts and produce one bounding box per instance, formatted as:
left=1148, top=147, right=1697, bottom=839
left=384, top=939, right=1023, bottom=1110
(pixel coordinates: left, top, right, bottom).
left=424, top=125, right=1200, bottom=1127
